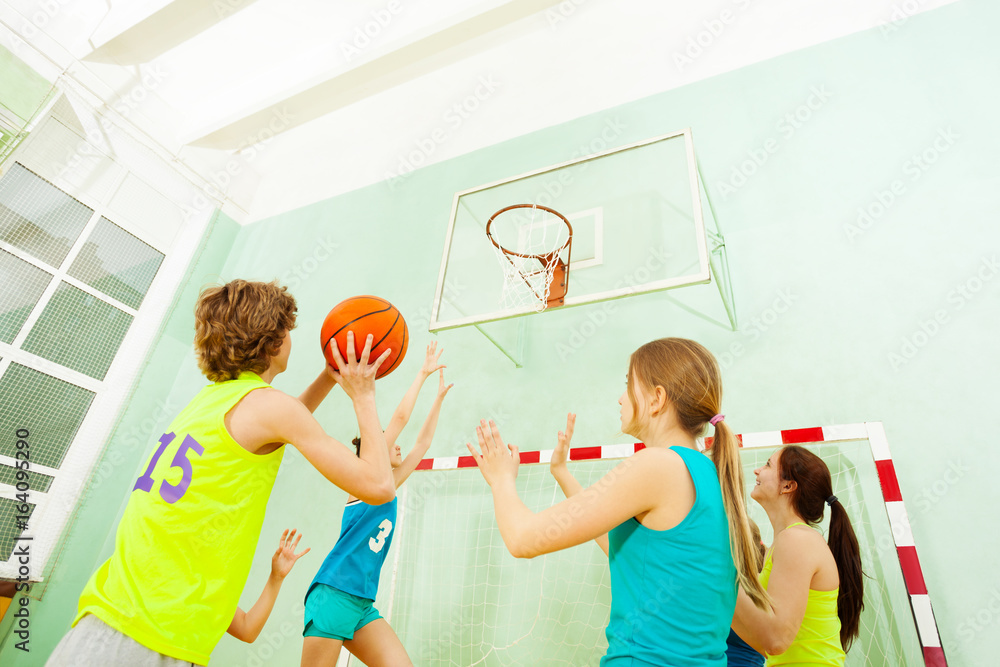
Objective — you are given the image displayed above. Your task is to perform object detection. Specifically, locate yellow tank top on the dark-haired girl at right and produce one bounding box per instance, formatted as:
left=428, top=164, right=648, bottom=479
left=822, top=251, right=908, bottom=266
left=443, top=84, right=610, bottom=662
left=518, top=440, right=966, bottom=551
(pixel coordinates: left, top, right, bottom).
left=760, top=522, right=847, bottom=667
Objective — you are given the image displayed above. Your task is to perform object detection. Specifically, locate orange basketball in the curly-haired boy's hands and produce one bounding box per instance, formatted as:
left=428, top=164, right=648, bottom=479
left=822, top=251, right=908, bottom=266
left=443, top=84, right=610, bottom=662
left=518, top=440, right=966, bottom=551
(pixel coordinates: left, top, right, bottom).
left=320, top=295, right=409, bottom=379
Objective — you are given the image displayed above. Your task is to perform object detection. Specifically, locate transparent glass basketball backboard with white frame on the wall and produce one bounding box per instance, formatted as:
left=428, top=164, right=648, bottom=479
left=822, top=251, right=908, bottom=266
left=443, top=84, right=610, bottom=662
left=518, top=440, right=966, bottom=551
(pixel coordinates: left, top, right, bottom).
left=430, top=129, right=711, bottom=331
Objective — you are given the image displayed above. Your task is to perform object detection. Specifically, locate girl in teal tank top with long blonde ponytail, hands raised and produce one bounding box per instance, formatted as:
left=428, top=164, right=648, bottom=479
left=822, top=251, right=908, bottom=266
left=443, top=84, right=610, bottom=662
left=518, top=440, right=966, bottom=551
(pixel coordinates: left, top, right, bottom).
left=469, top=338, right=768, bottom=667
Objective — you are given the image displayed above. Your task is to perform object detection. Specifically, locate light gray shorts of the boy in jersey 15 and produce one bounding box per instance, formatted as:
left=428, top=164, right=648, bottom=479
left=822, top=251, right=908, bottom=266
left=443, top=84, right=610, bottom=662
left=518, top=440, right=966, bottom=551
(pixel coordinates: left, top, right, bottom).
left=45, top=614, right=193, bottom=667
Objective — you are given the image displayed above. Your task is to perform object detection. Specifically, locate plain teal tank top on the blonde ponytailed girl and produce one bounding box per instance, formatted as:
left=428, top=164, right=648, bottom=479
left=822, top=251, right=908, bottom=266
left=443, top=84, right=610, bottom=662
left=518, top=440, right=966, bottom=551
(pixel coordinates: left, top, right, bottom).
left=601, top=447, right=736, bottom=667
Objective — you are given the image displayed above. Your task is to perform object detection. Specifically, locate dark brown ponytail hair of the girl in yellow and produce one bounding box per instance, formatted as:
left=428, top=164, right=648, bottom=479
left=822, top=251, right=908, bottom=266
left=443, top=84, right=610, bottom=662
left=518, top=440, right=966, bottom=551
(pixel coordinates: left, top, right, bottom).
left=778, top=445, right=865, bottom=651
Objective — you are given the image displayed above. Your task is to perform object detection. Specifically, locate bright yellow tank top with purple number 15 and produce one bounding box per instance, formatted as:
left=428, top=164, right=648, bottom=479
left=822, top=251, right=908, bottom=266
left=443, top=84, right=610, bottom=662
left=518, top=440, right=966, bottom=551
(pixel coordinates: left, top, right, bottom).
left=73, top=372, right=284, bottom=665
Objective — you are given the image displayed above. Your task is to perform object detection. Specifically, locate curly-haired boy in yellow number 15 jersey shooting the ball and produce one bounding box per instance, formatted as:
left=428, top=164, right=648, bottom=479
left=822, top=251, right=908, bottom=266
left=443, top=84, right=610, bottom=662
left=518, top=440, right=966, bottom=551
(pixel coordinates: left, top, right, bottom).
left=48, top=280, right=395, bottom=667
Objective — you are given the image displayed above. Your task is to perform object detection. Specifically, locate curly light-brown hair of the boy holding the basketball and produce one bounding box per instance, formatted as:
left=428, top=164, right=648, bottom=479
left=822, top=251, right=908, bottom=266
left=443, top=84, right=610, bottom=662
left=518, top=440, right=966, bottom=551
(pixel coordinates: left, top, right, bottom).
left=194, top=279, right=297, bottom=382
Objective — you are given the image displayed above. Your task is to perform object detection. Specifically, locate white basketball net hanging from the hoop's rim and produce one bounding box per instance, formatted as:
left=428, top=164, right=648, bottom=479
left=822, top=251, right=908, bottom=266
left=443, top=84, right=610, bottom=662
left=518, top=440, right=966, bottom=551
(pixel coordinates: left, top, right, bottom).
left=490, top=208, right=569, bottom=312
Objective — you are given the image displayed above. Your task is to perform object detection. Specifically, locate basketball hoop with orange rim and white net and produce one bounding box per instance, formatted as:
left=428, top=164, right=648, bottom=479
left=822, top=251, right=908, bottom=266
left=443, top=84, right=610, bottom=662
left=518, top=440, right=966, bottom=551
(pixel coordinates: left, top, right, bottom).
left=486, top=204, right=573, bottom=312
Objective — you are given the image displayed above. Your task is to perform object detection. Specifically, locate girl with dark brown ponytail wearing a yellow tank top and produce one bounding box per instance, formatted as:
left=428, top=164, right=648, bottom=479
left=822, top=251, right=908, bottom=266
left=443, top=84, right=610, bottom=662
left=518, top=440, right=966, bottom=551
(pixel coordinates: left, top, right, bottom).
left=733, top=445, right=864, bottom=666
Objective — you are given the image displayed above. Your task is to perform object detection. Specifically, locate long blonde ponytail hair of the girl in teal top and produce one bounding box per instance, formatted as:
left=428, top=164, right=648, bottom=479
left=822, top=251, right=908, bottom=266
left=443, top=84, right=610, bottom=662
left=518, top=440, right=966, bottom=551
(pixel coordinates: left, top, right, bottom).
left=625, top=338, right=771, bottom=609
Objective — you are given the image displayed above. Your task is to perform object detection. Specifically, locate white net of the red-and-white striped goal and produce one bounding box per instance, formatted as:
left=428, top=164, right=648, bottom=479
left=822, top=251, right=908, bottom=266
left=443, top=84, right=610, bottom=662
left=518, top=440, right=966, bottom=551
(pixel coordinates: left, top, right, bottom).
left=372, top=430, right=936, bottom=667
